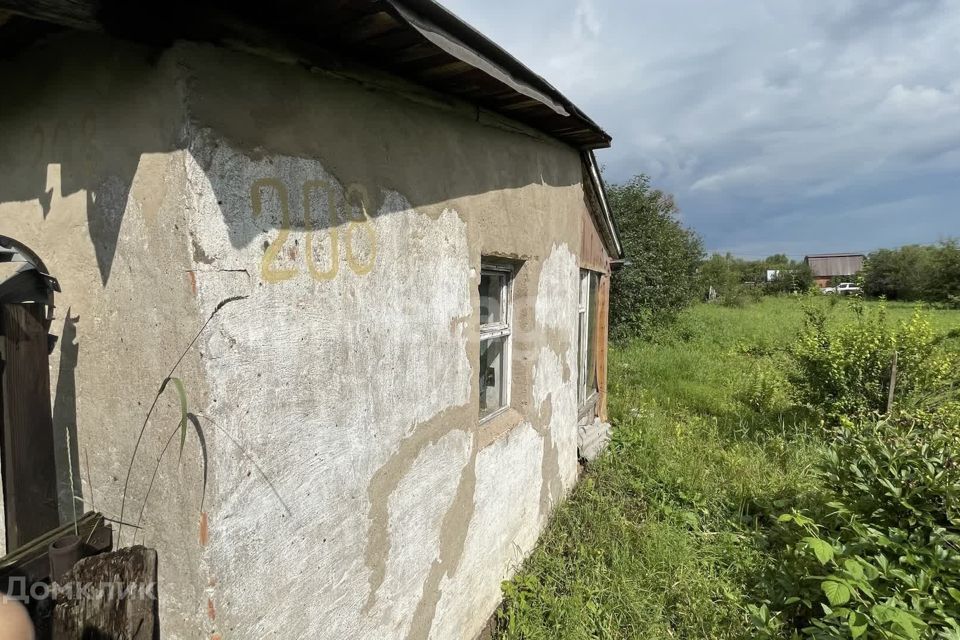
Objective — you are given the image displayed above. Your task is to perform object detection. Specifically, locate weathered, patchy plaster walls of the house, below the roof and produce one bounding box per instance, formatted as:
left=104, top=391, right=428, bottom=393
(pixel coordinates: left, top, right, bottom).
left=0, top=31, right=584, bottom=640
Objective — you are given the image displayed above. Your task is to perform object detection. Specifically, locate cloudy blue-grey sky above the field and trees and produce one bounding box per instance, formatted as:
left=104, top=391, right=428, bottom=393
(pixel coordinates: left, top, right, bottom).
left=442, top=0, right=960, bottom=257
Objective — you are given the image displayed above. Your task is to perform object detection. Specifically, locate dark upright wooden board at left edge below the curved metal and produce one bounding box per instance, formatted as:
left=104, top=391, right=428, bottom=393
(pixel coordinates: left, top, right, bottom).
left=0, top=304, right=60, bottom=551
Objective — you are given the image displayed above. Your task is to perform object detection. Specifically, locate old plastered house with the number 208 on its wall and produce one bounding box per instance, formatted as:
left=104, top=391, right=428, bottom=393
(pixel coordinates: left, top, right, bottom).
left=0, top=0, right=622, bottom=640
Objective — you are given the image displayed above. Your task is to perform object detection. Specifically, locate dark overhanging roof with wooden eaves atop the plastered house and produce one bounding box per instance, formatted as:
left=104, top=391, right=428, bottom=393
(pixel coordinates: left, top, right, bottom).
left=0, top=0, right=611, bottom=150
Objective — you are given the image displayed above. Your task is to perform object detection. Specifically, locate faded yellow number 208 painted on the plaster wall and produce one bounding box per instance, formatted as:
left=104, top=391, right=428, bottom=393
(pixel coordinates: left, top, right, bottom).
left=250, top=178, right=377, bottom=282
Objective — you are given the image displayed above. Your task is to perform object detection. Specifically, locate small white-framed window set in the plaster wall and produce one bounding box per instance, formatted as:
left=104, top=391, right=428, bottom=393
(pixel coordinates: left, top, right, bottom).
left=480, top=265, right=513, bottom=420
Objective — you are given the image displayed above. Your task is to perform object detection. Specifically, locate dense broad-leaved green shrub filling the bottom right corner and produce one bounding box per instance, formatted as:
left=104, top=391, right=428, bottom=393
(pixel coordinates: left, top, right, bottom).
left=750, top=405, right=960, bottom=639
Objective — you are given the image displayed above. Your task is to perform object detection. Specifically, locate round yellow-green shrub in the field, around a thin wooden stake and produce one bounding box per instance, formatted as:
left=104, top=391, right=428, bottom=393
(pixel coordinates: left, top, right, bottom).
left=791, top=301, right=956, bottom=417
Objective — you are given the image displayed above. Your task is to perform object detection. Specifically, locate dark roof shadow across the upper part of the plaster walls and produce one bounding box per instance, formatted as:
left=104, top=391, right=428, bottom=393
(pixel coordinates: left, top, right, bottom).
left=0, top=32, right=581, bottom=286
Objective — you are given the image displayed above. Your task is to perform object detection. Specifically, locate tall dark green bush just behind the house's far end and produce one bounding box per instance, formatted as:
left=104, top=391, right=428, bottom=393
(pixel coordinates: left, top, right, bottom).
left=608, top=176, right=703, bottom=339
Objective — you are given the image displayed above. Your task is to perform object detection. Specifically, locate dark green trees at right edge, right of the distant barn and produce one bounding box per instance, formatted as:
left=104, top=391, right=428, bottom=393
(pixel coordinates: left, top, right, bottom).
left=864, top=240, right=960, bottom=304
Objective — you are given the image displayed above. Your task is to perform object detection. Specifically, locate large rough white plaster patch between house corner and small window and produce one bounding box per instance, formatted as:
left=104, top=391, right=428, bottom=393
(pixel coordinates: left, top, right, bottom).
left=186, top=138, right=473, bottom=637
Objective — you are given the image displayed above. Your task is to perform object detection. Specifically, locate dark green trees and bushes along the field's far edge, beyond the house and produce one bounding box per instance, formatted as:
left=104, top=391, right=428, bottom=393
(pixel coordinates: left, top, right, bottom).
left=608, top=170, right=960, bottom=339
